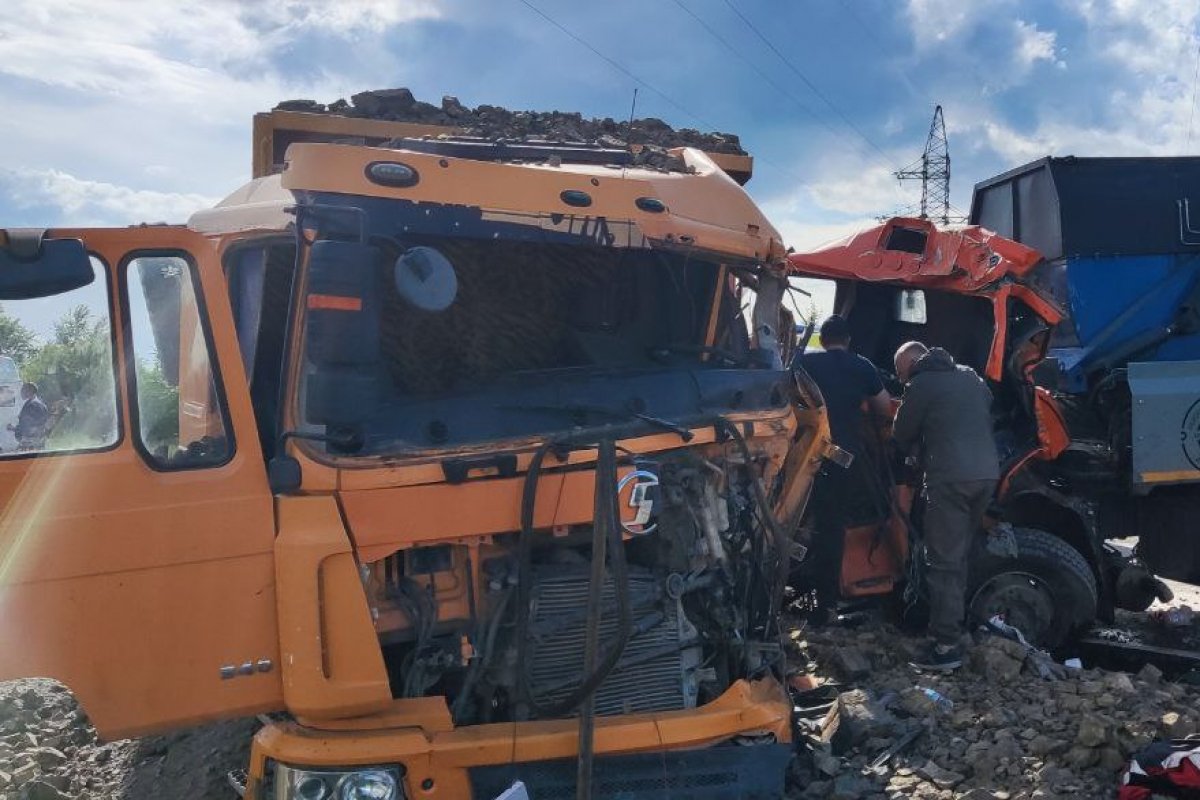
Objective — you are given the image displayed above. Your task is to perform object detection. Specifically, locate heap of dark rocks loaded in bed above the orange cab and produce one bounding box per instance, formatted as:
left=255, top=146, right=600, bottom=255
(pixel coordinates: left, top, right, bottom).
left=274, top=89, right=745, bottom=155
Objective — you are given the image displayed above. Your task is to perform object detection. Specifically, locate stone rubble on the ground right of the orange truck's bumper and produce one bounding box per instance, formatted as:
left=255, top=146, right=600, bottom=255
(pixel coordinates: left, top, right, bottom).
left=788, top=620, right=1200, bottom=800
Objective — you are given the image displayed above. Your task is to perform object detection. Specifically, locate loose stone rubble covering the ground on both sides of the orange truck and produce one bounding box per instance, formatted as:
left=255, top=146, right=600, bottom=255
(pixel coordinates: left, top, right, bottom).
left=0, top=585, right=1200, bottom=800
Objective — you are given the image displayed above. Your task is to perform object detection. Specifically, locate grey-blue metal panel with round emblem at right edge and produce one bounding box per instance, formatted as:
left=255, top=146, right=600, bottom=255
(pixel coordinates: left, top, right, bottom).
left=1129, top=361, right=1200, bottom=487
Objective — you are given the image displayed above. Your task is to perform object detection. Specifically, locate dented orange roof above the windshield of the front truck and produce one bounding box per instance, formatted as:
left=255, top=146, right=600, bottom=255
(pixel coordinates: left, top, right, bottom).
left=188, top=143, right=784, bottom=261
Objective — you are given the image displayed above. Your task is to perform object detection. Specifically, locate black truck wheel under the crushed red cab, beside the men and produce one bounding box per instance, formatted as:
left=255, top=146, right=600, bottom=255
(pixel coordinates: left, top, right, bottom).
left=967, top=528, right=1099, bottom=650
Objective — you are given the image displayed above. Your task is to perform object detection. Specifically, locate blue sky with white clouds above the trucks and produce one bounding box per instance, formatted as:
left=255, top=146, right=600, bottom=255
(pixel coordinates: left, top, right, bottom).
left=0, top=0, right=1200, bottom=326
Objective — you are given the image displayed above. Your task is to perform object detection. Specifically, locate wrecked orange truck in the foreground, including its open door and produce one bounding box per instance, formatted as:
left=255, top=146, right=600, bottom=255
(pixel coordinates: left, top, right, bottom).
left=0, top=112, right=829, bottom=800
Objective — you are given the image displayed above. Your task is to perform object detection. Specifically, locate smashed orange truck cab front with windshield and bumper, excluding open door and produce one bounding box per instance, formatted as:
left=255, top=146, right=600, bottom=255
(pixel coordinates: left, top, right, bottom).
left=223, top=143, right=824, bottom=798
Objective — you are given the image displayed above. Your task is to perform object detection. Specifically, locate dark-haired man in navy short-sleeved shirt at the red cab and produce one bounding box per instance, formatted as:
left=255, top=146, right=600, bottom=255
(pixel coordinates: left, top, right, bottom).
left=793, top=315, right=892, bottom=616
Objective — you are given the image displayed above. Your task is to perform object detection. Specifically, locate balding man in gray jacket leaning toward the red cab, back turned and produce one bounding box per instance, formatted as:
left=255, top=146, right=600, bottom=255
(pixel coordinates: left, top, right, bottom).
left=893, top=342, right=1000, bottom=669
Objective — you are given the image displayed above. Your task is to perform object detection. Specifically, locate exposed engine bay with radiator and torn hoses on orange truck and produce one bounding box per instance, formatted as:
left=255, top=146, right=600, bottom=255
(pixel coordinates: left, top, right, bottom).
left=364, top=448, right=782, bottom=724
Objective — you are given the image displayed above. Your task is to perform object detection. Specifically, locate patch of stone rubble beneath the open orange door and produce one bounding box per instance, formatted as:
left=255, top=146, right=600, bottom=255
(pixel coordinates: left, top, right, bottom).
left=0, top=679, right=258, bottom=800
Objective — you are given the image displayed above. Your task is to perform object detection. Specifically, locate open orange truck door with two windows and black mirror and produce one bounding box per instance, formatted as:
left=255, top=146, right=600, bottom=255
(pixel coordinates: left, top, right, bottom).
left=0, top=227, right=282, bottom=738
